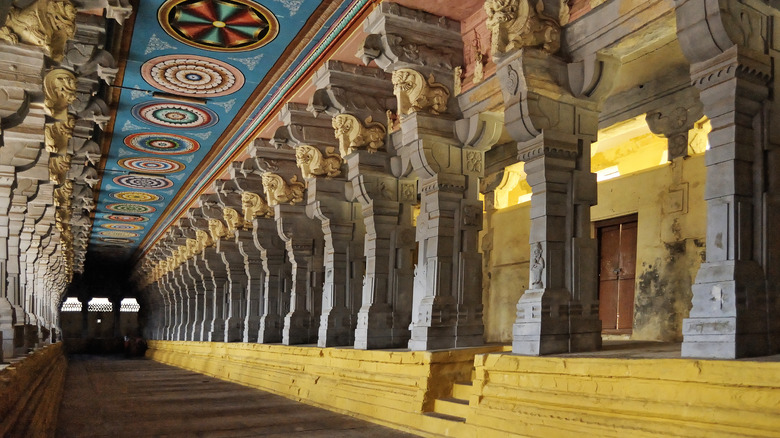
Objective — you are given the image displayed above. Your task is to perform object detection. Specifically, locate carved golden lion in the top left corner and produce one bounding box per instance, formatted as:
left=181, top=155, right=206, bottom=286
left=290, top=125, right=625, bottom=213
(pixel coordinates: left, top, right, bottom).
left=0, top=0, right=76, bottom=62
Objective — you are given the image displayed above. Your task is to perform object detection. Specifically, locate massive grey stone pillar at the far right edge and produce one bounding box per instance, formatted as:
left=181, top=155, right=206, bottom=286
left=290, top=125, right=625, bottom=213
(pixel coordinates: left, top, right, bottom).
left=676, top=0, right=780, bottom=358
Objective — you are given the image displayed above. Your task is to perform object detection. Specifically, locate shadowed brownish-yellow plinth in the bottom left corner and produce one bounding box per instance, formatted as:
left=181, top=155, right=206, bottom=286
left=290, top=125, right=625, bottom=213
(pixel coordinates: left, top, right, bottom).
left=0, top=342, right=67, bottom=438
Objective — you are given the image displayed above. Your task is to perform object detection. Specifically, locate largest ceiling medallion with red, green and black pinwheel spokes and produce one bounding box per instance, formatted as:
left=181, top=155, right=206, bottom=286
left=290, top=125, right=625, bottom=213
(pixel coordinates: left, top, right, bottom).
left=157, top=0, right=279, bottom=52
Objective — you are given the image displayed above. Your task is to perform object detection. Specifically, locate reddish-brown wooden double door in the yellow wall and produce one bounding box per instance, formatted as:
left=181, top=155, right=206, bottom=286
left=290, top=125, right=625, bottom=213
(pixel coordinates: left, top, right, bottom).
left=596, top=216, right=637, bottom=333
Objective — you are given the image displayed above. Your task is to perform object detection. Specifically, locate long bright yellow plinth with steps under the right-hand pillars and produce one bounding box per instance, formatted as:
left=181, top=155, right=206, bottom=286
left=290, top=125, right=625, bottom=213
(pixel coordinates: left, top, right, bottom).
left=147, top=341, right=780, bottom=438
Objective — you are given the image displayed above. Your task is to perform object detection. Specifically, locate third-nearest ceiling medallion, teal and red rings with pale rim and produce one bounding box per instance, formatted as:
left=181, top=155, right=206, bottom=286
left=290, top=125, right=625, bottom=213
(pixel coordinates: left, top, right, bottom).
left=133, top=102, right=219, bottom=129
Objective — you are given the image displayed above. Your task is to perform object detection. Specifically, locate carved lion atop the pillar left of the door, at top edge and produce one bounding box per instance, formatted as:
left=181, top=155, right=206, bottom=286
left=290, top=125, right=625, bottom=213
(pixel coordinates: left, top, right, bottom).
left=484, top=0, right=569, bottom=56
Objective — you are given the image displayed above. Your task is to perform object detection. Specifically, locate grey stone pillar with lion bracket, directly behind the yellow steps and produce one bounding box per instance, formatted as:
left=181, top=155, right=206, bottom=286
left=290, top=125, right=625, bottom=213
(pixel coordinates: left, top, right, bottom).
left=359, top=3, right=483, bottom=350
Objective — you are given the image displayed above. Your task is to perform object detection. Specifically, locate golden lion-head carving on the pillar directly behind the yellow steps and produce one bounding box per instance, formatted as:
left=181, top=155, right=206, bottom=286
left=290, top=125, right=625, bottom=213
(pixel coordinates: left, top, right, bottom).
left=393, top=68, right=450, bottom=115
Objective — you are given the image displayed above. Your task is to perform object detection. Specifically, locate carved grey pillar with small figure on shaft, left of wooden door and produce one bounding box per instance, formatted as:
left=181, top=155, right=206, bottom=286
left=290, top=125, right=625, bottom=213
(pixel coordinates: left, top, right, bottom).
left=485, top=14, right=611, bottom=355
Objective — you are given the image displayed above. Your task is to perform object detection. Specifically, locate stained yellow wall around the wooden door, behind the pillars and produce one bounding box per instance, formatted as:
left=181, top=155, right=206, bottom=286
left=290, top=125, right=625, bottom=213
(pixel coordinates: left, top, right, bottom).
left=482, top=154, right=706, bottom=342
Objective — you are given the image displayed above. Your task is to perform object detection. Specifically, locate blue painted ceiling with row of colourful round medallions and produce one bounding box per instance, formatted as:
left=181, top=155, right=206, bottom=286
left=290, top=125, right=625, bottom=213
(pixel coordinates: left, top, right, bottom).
left=89, top=0, right=367, bottom=259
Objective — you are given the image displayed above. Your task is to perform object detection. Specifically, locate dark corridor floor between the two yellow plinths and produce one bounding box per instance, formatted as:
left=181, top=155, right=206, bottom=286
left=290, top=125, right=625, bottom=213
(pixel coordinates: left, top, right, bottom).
left=57, top=355, right=413, bottom=438
